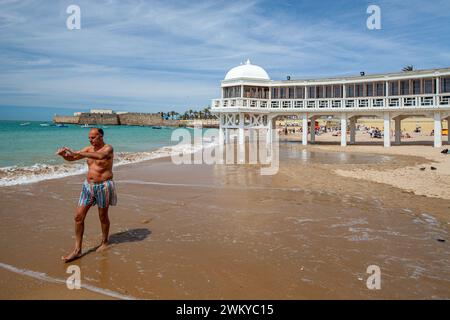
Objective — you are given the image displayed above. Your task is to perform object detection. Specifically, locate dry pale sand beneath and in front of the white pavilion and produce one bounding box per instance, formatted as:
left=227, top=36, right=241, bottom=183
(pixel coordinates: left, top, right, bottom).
left=282, top=132, right=450, bottom=200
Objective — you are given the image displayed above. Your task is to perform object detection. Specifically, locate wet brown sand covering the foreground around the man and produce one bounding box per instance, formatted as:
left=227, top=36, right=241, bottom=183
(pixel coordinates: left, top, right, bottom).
left=0, top=143, right=450, bottom=299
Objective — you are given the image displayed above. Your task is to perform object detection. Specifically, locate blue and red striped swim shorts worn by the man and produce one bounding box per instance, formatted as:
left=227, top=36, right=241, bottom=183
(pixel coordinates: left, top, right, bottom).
left=78, top=180, right=117, bottom=208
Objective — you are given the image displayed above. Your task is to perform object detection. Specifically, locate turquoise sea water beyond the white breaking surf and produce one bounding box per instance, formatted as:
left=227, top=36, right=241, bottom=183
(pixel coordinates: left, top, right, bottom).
left=0, top=121, right=183, bottom=168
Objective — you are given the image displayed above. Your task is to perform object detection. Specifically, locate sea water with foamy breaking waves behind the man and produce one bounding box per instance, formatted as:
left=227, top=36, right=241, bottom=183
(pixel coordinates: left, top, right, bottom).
left=0, top=121, right=196, bottom=186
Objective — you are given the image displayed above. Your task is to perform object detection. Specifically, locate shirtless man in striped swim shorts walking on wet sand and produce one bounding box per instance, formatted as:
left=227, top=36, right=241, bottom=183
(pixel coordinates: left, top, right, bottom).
left=56, top=128, right=117, bottom=262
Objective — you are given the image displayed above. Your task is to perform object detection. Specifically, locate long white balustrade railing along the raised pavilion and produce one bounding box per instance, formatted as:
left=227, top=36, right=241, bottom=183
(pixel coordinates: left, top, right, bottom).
left=211, top=93, right=450, bottom=110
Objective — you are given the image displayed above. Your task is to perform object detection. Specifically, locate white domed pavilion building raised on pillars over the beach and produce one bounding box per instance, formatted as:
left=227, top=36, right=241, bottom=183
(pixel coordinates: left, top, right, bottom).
left=212, top=60, right=450, bottom=147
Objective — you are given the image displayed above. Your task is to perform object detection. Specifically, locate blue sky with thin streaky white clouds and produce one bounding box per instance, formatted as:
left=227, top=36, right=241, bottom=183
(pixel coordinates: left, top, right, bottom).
left=0, top=0, right=450, bottom=118
